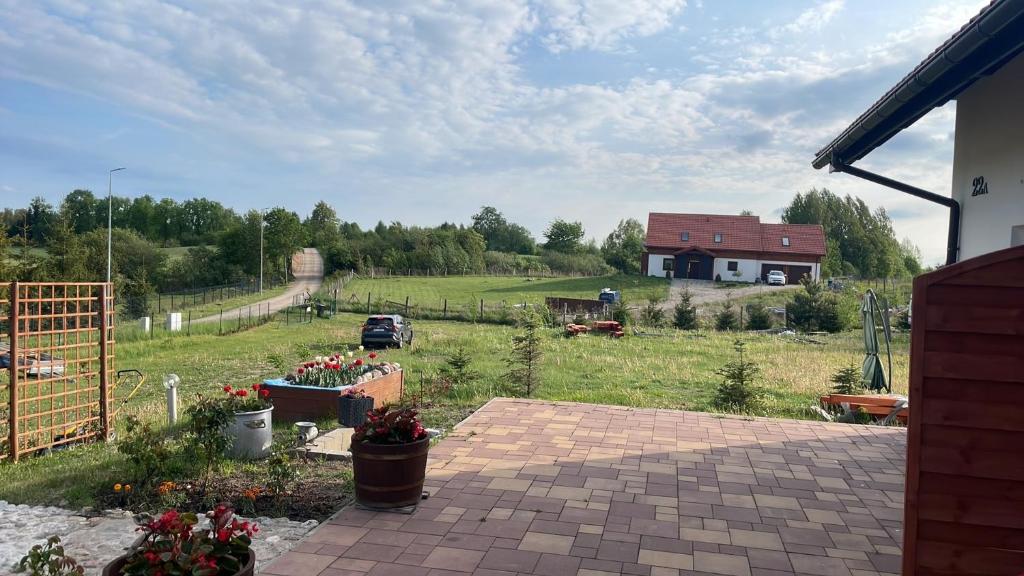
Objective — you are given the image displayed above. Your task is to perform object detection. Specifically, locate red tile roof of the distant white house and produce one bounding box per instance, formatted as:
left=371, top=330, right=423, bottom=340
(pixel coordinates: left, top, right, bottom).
left=645, top=212, right=825, bottom=256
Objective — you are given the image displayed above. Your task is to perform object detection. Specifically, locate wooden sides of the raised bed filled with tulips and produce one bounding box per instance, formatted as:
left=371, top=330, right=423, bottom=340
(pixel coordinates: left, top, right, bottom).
left=263, top=370, right=406, bottom=422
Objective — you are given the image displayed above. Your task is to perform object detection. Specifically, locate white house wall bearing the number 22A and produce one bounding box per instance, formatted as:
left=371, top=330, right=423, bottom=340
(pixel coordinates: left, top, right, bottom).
left=952, top=54, right=1024, bottom=259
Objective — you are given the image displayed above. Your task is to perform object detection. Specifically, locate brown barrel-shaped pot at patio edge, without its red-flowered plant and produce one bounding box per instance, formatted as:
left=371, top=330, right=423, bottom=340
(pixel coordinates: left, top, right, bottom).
left=349, top=438, right=430, bottom=508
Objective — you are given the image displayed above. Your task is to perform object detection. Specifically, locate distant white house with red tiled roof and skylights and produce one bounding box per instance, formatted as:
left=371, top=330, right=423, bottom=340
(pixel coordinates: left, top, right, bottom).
left=640, top=212, right=825, bottom=284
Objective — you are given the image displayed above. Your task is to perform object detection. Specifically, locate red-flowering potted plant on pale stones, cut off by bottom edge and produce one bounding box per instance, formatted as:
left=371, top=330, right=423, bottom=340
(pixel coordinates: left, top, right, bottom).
left=102, top=504, right=259, bottom=576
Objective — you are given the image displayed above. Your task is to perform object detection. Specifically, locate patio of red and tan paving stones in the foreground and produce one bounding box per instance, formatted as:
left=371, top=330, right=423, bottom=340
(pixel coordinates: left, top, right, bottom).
left=262, top=399, right=906, bottom=576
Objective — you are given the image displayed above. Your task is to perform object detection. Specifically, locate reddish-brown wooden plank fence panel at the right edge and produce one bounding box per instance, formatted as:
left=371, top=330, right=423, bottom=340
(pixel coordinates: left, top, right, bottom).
left=903, top=246, right=1024, bottom=576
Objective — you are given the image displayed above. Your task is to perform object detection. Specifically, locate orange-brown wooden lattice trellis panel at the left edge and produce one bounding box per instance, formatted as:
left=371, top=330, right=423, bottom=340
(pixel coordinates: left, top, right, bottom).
left=0, top=282, right=115, bottom=460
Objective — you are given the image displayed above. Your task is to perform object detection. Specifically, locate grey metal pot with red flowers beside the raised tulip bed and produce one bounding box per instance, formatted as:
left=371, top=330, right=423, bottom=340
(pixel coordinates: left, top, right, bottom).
left=223, top=384, right=273, bottom=459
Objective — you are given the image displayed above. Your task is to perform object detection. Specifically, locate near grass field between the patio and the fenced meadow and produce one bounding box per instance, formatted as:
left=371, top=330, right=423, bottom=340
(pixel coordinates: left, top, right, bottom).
left=0, top=314, right=908, bottom=506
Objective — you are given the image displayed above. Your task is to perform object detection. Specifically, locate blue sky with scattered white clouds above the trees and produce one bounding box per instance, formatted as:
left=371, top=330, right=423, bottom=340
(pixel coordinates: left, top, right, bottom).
left=0, top=0, right=986, bottom=263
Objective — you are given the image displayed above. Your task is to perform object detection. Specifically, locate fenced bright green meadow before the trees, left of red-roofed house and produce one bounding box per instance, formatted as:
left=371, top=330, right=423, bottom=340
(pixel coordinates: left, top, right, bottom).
left=341, top=275, right=669, bottom=310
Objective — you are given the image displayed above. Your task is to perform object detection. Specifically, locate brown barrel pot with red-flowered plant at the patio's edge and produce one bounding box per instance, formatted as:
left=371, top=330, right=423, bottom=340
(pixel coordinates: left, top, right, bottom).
left=349, top=407, right=430, bottom=508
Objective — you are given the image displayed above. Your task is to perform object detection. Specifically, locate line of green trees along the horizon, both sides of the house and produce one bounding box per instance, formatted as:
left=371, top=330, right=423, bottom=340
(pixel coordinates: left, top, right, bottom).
left=0, top=190, right=921, bottom=294
